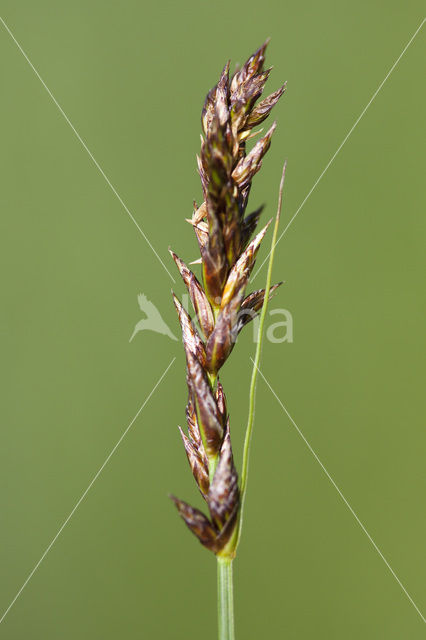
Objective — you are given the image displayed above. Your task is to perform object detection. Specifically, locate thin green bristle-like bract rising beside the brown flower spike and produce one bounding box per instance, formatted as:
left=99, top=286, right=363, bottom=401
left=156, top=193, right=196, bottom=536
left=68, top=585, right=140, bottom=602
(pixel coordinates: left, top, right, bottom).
left=236, top=162, right=287, bottom=547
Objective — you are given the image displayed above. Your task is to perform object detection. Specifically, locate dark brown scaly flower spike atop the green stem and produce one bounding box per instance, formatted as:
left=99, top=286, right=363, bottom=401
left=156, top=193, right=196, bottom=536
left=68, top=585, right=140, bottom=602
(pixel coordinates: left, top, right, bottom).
left=171, top=42, right=285, bottom=557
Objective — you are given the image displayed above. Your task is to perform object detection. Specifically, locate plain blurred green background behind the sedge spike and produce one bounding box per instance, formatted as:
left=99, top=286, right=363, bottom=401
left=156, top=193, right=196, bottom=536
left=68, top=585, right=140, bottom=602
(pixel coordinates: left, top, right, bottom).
left=0, top=0, right=426, bottom=640
